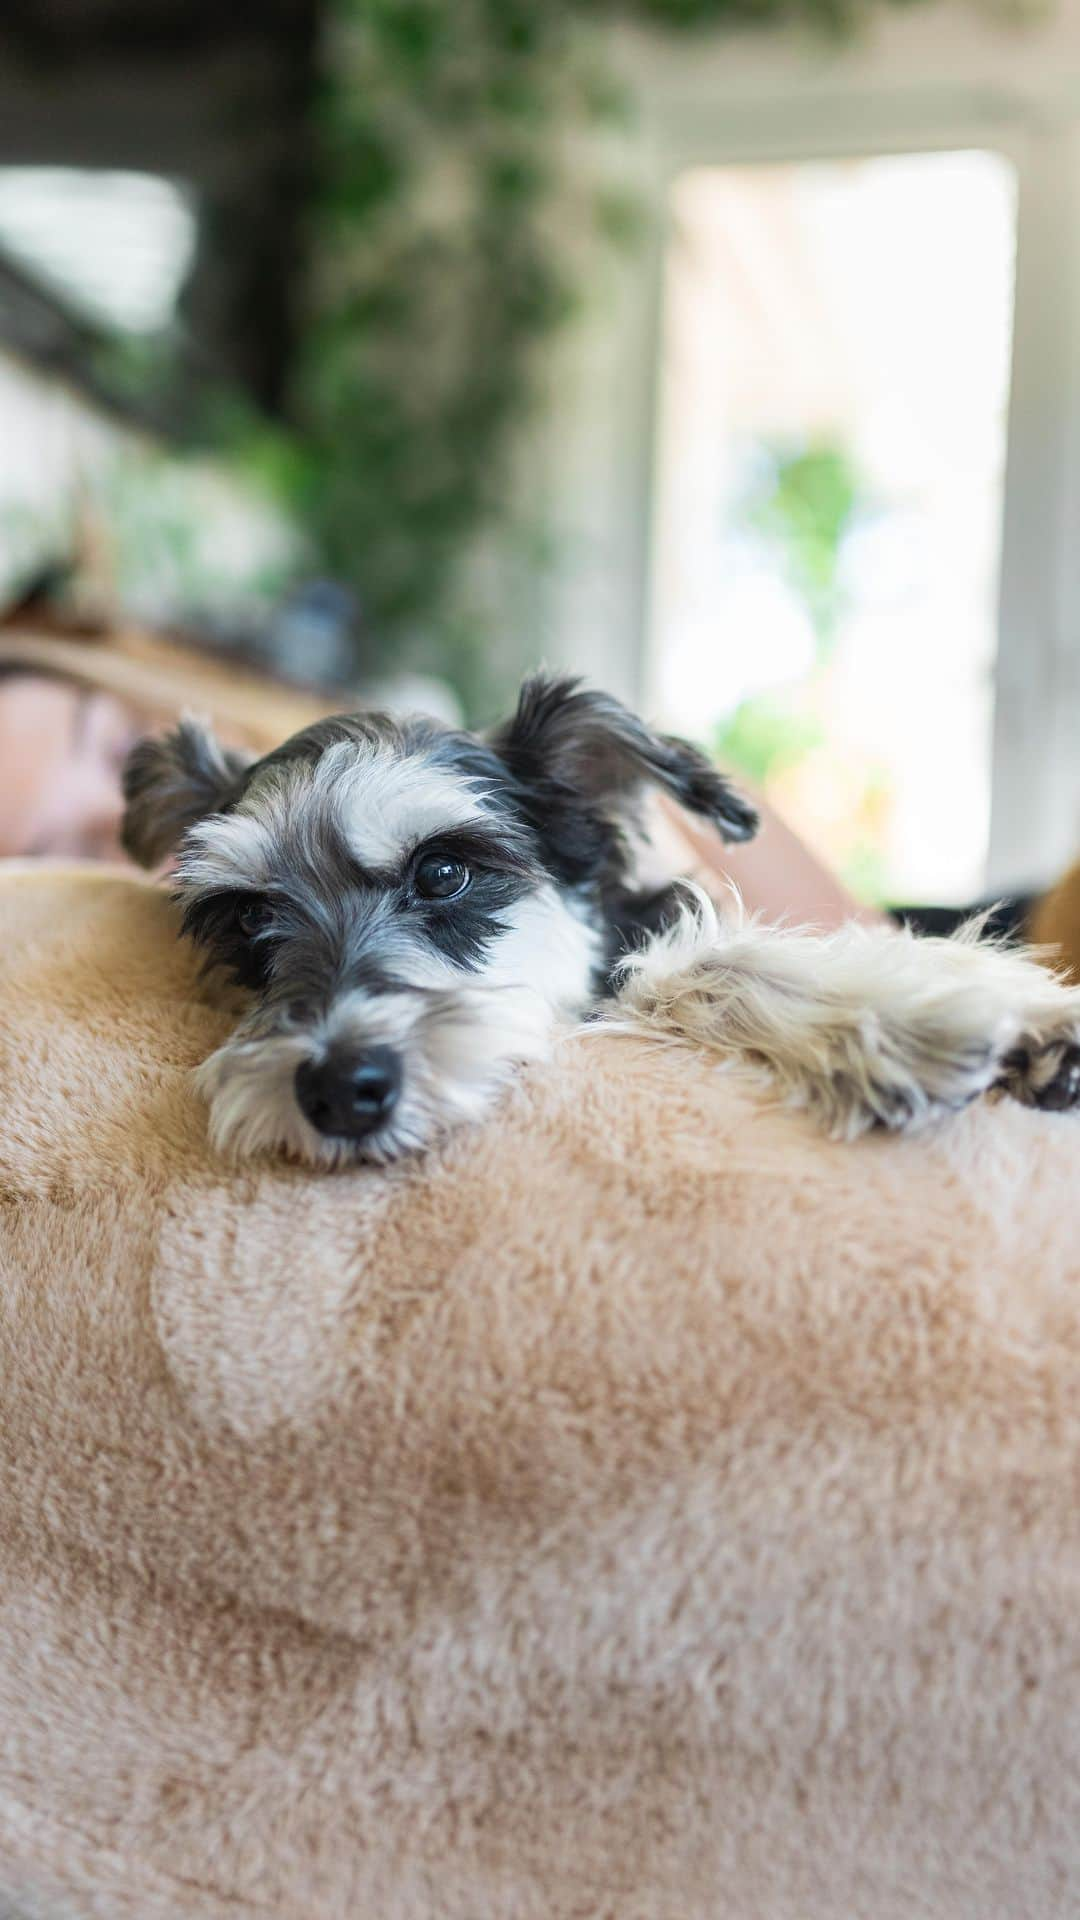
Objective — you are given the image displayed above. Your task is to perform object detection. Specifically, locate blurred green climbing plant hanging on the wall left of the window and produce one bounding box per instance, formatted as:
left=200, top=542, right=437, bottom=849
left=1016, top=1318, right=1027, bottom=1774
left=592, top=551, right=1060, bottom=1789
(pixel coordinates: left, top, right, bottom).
left=282, top=0, right=930, bottom=695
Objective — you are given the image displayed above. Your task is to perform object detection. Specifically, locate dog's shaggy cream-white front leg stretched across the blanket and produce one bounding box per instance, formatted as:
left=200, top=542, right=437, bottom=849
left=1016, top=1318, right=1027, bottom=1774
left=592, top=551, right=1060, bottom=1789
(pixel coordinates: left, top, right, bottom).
left=607, top=897, right=1080, bottom=1139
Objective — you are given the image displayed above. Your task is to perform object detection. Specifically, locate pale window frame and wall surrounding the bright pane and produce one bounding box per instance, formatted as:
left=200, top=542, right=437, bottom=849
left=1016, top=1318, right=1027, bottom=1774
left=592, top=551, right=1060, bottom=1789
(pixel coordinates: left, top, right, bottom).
left=555, top=0, right=1080, bottom=891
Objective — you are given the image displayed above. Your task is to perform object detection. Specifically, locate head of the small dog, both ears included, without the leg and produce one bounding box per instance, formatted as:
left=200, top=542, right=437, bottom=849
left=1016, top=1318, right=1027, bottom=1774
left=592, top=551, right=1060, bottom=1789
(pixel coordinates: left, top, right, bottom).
left=123, top=678, right=757, bottom=1164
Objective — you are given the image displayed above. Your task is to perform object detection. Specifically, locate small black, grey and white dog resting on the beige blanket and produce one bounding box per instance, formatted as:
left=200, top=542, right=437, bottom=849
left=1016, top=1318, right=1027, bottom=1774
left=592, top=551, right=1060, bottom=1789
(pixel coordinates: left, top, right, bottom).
left=123, top=676, right=1080, bottom=1165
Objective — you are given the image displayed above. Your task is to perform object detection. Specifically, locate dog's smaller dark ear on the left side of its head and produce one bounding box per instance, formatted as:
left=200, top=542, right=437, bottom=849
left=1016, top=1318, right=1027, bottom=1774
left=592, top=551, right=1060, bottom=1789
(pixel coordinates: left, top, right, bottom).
left=121, top=720, right=254, bottom=866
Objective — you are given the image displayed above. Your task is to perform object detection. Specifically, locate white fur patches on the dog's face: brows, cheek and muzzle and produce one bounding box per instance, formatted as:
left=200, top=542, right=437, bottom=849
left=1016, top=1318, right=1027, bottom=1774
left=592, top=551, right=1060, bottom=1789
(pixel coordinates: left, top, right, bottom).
left=183, top=741, right=601, bottom=1165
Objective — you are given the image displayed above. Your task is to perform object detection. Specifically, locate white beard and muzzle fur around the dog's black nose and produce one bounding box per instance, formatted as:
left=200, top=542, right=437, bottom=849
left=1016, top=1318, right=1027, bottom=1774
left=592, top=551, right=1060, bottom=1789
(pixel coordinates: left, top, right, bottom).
left=196, top=985, right=557, bottom=1167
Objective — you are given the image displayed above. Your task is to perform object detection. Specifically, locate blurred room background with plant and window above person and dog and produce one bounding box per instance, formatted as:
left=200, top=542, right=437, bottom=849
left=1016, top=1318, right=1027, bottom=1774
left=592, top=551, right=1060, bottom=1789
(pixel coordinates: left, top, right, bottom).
left=0, top=0, right=1080, bottom=902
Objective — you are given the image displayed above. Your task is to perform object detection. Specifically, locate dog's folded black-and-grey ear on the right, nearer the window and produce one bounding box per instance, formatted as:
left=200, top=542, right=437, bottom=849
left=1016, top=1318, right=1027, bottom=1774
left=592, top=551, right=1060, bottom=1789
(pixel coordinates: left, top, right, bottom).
left=492, top=674, right=757, bottom=841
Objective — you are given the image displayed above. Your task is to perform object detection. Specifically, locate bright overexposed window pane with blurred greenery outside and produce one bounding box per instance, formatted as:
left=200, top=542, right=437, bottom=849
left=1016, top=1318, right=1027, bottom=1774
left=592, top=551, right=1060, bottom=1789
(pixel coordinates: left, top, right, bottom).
left=650, top=152, right=1017, bottom=900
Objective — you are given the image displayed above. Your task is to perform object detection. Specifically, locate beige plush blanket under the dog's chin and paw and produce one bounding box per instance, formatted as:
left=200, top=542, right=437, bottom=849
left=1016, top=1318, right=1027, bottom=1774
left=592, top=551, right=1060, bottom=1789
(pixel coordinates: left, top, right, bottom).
left=0, top=874, right=1080, bottom=1920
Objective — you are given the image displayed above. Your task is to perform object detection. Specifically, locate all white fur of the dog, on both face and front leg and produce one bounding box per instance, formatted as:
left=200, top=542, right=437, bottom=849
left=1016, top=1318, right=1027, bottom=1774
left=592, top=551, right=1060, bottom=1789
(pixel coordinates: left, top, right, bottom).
left=181, top=721, right=1080, bottom=1164
